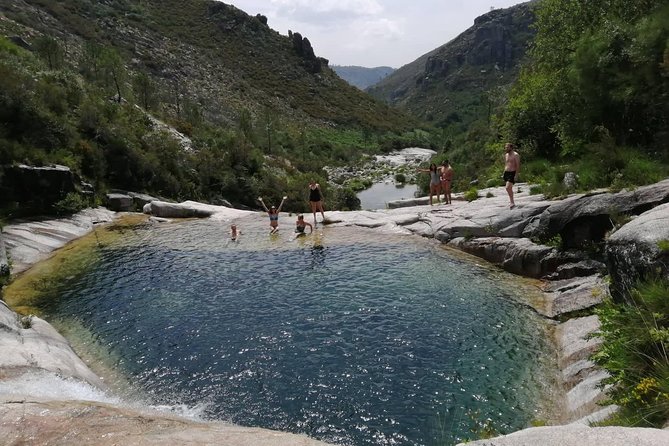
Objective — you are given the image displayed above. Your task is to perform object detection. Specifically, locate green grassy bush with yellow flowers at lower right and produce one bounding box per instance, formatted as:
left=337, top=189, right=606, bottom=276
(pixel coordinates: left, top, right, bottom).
left=593, top=280, right=669, bottom=427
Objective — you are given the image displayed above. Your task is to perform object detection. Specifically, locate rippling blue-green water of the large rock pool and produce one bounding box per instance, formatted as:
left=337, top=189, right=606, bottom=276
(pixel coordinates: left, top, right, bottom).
left=40, top=217, right=551, bottom=445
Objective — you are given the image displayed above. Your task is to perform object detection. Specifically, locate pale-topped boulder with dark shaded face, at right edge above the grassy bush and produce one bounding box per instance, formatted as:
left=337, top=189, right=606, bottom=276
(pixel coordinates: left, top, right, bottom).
left=605, top=204, right=669, bottom=297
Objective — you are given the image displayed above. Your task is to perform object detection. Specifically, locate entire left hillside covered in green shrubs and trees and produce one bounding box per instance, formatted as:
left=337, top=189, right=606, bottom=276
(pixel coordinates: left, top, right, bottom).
left=0, top=0, right=422, bottom=216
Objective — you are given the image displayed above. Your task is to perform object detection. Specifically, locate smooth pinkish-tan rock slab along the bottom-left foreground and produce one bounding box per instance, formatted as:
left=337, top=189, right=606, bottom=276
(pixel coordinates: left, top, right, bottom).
left=0, top=395, right=327, bottom=446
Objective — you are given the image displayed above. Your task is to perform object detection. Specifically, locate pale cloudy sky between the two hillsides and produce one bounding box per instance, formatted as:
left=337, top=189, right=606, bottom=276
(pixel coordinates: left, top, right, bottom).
left=223, top=0, right=523, bottom=68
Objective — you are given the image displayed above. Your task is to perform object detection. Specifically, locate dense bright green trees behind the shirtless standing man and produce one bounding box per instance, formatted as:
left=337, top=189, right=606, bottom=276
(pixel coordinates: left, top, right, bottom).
left=490, top=0, right=669, bottom=190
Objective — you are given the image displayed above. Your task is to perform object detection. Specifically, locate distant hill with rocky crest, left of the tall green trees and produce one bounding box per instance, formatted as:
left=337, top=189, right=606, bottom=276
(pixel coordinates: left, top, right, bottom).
left=367, top=1, right=536, bottom=127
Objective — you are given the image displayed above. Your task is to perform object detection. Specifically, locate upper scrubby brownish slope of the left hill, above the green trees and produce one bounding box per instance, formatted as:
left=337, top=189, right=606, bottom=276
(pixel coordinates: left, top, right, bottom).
left=0, top=0, right=415, bottom=130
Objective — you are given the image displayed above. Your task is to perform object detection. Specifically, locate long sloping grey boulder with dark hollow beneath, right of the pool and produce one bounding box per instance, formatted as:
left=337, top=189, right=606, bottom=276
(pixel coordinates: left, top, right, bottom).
left=524, top=180, right=669, bottom=248
